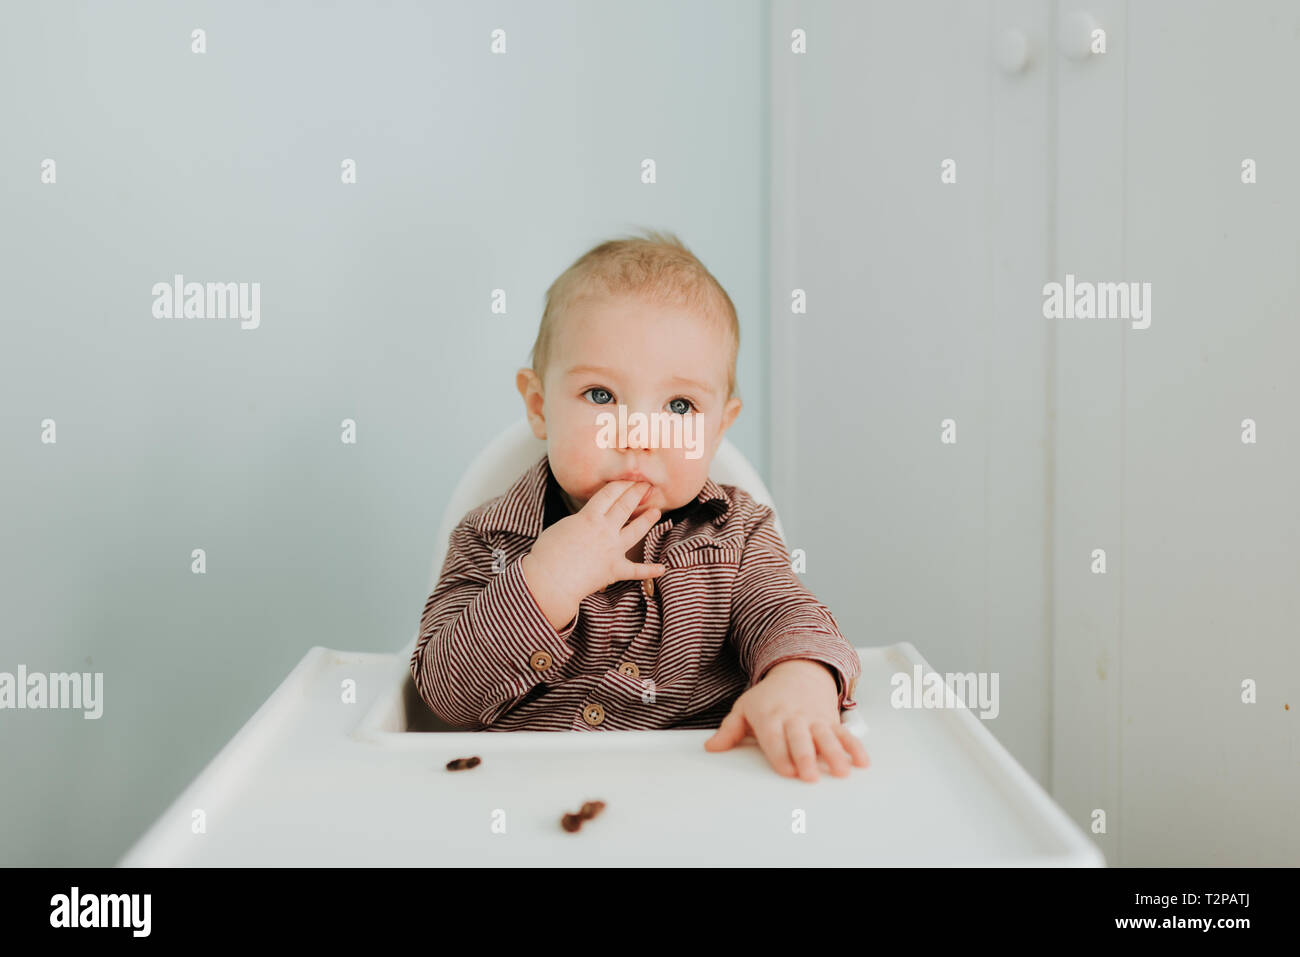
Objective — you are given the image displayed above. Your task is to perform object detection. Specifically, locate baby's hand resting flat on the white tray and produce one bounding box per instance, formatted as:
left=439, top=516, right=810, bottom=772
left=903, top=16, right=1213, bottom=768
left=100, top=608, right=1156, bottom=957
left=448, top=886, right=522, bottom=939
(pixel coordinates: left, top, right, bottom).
left=705, top=658, right=867, bottom=781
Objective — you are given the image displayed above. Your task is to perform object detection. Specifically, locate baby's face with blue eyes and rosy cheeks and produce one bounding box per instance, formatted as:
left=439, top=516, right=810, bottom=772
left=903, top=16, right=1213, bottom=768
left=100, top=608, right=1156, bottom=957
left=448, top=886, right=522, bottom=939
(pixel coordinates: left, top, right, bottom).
left=519, top=295, right=741, bottom=515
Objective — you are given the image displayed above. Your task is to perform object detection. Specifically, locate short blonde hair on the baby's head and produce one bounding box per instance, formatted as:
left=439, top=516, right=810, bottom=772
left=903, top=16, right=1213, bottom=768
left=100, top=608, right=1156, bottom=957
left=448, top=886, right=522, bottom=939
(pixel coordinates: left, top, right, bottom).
left=529, top=230, right=740, bottom=400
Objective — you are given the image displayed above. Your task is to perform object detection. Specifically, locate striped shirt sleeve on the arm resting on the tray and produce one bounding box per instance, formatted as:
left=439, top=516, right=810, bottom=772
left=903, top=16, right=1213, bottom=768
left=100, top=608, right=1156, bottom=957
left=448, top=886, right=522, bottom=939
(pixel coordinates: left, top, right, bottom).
left=731, top=506, right=862, bottom=711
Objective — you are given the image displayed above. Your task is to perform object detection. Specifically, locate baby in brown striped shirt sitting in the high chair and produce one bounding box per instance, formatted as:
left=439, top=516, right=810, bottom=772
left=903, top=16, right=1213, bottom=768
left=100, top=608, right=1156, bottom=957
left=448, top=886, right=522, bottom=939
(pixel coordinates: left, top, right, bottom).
left=411, top=231, right=867, bottom=781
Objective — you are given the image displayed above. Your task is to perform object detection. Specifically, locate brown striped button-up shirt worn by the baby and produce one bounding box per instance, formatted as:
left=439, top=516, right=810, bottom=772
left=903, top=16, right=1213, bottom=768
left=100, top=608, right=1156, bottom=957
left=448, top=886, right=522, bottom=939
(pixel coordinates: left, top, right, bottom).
left=411, top=455, right=862, bottom=731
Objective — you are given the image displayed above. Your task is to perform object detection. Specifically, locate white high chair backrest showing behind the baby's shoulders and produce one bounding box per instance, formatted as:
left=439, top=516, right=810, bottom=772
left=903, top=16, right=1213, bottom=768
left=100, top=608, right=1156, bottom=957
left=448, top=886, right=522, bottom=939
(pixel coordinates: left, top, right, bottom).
left=429, top=419, right=785, bottom=593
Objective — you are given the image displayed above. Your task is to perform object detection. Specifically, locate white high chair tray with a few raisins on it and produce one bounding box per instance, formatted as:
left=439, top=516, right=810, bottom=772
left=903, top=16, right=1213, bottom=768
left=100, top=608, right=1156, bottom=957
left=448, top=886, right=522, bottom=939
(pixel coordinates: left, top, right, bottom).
left=120, top=644, right=1105, bottom=867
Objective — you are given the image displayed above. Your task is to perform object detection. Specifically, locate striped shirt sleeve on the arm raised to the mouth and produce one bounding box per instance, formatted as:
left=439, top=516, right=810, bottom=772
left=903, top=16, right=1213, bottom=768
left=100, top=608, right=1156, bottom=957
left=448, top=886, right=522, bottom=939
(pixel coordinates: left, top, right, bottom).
left=411, top=521, right=581, bottom=731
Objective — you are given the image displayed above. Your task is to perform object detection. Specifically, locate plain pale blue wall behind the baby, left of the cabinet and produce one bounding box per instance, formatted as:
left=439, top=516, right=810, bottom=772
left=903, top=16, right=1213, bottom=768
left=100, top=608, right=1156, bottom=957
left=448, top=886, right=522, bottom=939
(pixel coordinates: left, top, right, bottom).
left=0, top=0, right=768, bottom=865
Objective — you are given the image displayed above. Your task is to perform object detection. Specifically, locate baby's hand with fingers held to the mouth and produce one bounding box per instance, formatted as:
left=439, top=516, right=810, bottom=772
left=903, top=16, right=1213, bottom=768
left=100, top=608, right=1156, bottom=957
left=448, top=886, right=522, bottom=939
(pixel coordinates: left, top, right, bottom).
left=528, top=480, right=667, bottom=603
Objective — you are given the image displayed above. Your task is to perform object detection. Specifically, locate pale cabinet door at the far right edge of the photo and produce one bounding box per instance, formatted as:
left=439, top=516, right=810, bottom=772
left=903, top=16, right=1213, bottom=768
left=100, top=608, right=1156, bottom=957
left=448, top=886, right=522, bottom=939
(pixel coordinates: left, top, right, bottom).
left=1052, top=0, right=1300, bottom=866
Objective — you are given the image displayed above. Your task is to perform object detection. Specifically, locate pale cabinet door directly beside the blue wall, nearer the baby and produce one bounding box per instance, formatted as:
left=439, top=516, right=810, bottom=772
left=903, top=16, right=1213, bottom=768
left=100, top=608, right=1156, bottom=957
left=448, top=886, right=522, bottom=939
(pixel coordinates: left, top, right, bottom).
left=770, top=0, right=1056, bottom=785
